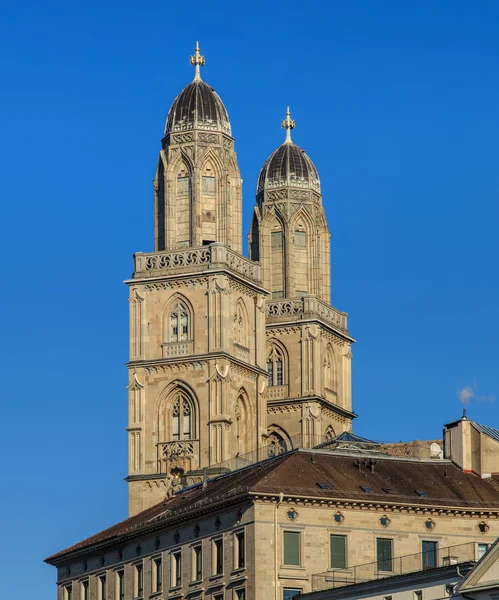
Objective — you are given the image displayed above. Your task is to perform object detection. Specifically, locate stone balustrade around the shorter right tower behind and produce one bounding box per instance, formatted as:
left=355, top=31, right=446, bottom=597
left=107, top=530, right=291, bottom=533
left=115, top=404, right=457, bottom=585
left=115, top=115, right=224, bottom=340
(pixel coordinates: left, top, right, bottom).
left=266, top=296, right=347, bottom=332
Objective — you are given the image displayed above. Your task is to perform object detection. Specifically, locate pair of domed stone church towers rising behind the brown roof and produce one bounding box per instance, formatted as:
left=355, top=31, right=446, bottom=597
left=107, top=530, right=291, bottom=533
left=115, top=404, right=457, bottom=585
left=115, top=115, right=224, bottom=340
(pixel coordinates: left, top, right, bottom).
left=127, top=45, right=355, bottom=515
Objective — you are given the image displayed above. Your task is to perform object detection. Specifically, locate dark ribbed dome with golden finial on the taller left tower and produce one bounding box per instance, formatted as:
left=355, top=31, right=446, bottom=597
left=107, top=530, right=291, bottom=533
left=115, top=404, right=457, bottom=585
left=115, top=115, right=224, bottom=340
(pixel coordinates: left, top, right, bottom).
left=165, top=42, right=230, bottom=135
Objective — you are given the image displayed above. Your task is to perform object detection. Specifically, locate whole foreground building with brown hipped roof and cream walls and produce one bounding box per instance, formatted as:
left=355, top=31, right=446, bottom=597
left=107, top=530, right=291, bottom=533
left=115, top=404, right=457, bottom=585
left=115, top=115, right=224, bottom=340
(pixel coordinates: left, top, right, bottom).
left=47, top=448, right=499, bottom=600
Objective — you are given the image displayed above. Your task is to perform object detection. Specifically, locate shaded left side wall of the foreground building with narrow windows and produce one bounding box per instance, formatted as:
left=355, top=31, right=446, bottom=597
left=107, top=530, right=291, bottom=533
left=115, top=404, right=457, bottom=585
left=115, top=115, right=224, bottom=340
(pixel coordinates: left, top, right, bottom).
left=58, top=504, right=258, bottom=600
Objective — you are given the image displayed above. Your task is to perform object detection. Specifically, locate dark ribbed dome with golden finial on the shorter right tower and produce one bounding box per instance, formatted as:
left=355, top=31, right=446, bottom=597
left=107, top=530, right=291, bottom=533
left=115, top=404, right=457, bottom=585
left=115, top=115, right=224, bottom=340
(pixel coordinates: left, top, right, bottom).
left=256, top=107, right=321, bottom=193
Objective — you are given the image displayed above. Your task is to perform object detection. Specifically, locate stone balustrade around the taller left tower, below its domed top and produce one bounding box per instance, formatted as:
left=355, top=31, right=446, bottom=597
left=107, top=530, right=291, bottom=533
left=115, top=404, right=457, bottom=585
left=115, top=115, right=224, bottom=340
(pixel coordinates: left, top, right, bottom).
left=133, top=244, right=260, bottom=282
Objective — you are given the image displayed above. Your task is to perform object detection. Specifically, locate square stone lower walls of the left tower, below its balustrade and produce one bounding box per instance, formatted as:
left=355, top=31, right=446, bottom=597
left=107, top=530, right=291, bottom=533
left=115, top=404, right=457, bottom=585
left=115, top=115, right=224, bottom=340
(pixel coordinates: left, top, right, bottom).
left=128, top=273, right=266, bottom=514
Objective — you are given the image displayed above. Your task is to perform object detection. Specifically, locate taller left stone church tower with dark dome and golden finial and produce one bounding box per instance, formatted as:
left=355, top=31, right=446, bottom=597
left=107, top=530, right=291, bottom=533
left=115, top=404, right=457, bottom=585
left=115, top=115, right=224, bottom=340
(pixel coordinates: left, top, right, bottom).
left=127, top=44, right=267, bottom=515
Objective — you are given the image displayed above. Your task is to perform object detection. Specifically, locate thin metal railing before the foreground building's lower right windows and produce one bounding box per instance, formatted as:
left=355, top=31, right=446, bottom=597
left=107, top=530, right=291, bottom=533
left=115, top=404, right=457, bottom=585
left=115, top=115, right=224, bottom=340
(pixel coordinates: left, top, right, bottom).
left=312, top=542, right=480, bottom=592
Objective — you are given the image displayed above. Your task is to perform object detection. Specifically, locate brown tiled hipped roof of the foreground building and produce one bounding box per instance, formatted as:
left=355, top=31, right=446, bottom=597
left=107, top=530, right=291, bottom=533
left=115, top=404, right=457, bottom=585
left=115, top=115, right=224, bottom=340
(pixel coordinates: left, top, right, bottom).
left=46, top=450, right=499, bottom=562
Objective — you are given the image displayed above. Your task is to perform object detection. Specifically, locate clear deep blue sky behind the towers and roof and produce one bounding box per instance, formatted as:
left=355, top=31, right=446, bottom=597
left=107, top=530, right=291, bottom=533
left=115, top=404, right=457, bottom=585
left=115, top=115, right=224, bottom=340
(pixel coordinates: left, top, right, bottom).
left=0, top=0, right=499, bottom=600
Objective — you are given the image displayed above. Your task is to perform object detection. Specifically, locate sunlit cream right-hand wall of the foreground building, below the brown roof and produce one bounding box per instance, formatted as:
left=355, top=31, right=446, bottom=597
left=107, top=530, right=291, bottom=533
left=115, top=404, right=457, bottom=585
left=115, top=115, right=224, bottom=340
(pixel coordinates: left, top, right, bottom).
left=255, top=501, right=499, bottom=600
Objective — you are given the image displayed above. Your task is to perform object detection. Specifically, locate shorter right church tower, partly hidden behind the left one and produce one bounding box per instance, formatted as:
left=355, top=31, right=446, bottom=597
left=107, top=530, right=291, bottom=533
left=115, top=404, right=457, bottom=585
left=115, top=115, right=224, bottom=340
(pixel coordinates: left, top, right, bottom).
left=249, top=108, right=355, bottom=449
